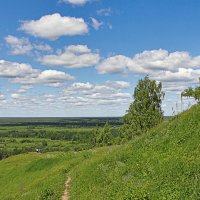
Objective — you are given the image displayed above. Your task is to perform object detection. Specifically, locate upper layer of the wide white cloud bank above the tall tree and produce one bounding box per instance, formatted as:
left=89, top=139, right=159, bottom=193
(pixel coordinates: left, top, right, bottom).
left=97, top=49, right=200, bottom=74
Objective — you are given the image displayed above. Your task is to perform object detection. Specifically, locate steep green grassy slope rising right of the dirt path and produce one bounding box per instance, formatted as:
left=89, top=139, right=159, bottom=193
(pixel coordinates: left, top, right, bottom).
left=70, top=105, right=200, bottom=200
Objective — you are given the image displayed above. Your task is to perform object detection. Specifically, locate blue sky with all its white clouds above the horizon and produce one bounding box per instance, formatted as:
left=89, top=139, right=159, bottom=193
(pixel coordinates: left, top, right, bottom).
left=0, top=0, right=200, bottom=117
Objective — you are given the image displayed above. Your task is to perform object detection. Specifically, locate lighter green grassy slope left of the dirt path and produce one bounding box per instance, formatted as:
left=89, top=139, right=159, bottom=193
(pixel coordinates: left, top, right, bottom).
left=0, top=147, right=119, bottom=200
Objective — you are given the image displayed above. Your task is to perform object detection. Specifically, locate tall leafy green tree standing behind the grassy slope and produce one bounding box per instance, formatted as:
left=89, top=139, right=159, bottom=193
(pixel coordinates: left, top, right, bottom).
left=121, top=76, right=164, bottom=139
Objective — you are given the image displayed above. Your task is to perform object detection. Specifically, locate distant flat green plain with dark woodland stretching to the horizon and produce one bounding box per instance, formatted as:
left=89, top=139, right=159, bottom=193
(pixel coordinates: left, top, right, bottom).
left=0, top=118, right=122, bottom=159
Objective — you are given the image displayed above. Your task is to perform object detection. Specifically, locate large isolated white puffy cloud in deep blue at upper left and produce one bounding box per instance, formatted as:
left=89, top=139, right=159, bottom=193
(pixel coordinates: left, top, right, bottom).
left=19, top=13, right=88, bottom=40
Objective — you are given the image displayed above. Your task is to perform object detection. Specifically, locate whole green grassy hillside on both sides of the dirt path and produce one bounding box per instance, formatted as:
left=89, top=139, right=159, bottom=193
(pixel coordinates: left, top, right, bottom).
left=0, top=105, right=200, bottom=200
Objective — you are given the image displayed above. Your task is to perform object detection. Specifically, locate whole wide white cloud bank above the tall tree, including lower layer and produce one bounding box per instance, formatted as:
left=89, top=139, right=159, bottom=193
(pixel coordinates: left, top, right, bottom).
left=97, top=49, right=200, bottom=83
